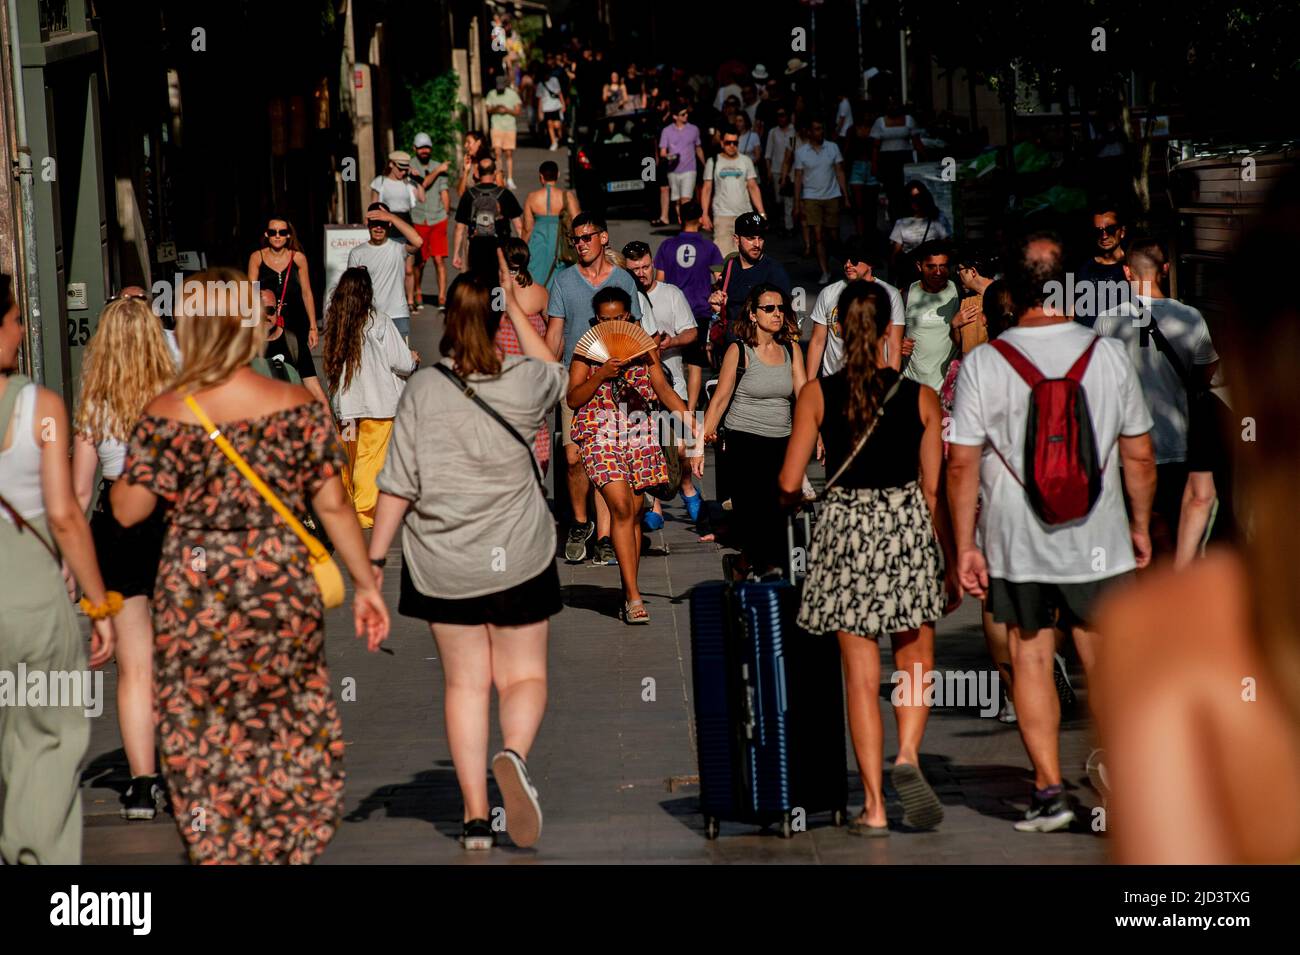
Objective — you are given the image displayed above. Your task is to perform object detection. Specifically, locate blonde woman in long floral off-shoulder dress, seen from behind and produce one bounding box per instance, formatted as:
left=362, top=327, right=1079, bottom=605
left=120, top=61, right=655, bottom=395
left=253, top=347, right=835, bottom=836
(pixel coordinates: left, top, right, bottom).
left=109, top=269, right=389, bottom=863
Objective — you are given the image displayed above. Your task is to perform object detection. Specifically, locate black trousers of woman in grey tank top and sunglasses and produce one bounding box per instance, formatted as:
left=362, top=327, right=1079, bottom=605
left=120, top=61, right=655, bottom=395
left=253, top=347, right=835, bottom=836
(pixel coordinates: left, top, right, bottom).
left=727, top=430, right=790, bottom=573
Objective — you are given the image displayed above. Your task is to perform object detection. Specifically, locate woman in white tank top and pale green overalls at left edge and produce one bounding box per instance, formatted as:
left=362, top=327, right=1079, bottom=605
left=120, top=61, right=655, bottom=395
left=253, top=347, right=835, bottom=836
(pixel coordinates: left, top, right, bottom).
left=0, top=274, right=121, bottom=865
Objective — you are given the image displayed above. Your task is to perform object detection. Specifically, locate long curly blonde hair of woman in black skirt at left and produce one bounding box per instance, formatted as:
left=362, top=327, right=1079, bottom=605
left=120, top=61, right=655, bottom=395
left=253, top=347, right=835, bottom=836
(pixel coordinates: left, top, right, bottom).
left=77, top=299, right=176, bottom=443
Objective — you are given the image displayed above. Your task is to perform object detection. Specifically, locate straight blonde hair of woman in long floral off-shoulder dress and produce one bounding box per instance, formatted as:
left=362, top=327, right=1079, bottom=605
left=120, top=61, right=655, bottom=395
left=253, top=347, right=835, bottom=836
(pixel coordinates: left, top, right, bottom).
left=173, top=269, right=267, bottom=392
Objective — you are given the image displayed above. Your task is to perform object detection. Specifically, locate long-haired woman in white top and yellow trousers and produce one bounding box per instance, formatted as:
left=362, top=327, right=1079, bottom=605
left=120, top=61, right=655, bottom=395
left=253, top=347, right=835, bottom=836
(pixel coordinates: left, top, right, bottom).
left=322, top=269, right=420, bottom=528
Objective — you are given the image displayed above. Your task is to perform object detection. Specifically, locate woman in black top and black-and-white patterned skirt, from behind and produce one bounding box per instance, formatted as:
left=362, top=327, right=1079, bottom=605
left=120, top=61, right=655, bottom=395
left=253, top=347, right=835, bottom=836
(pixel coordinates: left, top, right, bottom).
left=781, top=279, right=961, bottom=835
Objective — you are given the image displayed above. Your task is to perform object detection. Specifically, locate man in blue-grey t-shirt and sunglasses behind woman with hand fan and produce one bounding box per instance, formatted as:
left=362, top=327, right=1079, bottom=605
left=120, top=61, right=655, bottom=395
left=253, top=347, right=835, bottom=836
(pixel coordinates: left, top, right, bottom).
left=546, top=212, right=641, bottom=564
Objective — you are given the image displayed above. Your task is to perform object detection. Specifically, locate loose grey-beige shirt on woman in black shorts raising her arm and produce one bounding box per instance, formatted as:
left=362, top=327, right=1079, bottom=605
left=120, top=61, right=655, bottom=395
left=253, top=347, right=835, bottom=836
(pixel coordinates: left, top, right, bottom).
left=377, top=355, right=568, bottom=600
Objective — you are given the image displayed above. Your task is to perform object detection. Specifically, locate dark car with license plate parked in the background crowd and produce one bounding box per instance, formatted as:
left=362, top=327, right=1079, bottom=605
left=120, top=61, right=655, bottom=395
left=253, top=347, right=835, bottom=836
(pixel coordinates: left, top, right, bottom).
left=569, top=110, right=662, bottom=218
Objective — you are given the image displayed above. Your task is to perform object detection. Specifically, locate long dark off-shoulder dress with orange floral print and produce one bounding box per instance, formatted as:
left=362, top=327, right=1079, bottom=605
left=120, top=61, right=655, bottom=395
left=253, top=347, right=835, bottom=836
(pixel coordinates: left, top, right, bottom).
left=124, top=401, right=346, bottom=863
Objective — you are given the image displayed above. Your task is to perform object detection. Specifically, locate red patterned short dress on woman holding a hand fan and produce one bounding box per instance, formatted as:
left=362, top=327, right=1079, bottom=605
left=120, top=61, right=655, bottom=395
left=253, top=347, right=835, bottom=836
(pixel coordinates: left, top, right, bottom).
left=572, top=359, right=668, bottom=491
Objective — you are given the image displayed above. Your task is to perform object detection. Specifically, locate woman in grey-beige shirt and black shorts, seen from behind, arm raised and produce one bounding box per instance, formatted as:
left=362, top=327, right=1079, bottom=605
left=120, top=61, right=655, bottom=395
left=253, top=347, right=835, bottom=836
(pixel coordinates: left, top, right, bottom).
left=371, top=265, right=566, bottom=850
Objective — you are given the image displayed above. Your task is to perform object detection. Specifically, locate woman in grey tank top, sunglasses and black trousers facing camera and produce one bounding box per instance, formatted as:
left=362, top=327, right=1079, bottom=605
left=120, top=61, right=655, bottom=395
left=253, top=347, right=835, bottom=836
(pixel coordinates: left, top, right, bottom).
left=705, top=282, right=806, bottom=576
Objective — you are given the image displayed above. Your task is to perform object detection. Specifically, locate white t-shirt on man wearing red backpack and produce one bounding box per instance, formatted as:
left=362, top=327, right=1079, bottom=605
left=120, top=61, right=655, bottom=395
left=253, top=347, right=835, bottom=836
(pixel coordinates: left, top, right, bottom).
left=949, top=321, right=1152, bottom=583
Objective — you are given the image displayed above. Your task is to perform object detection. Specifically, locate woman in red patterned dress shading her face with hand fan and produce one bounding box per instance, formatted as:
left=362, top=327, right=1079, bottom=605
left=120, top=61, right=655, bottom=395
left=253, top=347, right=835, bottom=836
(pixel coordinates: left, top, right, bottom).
left=568, top=286, right=705, bottom=624
